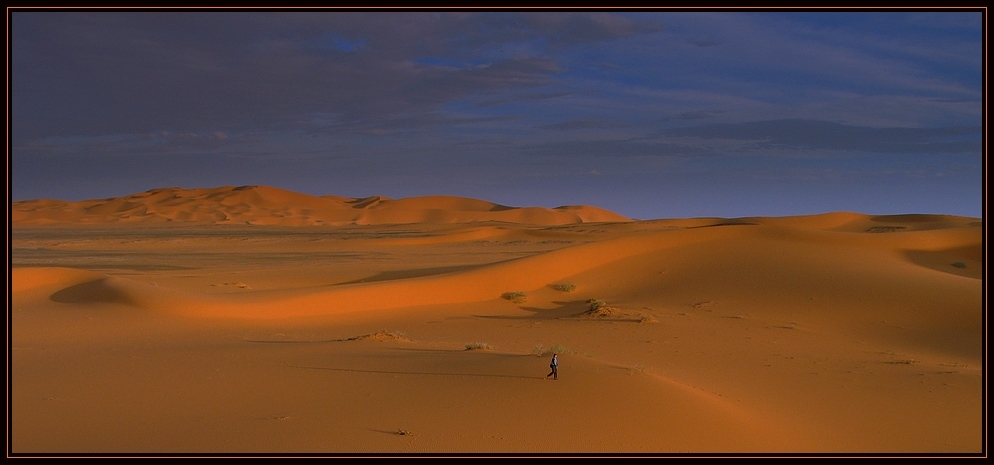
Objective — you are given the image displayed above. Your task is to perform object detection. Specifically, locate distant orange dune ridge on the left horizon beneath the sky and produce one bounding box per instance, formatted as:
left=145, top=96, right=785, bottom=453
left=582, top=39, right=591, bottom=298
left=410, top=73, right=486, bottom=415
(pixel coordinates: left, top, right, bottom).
left=11, top=186, right=631, bottom=226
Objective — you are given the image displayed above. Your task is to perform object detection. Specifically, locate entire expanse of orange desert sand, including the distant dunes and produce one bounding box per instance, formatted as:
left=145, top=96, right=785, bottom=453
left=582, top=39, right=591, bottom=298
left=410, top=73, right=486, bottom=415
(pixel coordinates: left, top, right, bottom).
left=10, top=187, right=985, bottom=453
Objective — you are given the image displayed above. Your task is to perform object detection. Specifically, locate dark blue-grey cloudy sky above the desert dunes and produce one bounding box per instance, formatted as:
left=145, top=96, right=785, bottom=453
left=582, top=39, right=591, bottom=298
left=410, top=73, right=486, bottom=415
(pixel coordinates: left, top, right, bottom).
left=8, top=9, right=986, bottom=219
